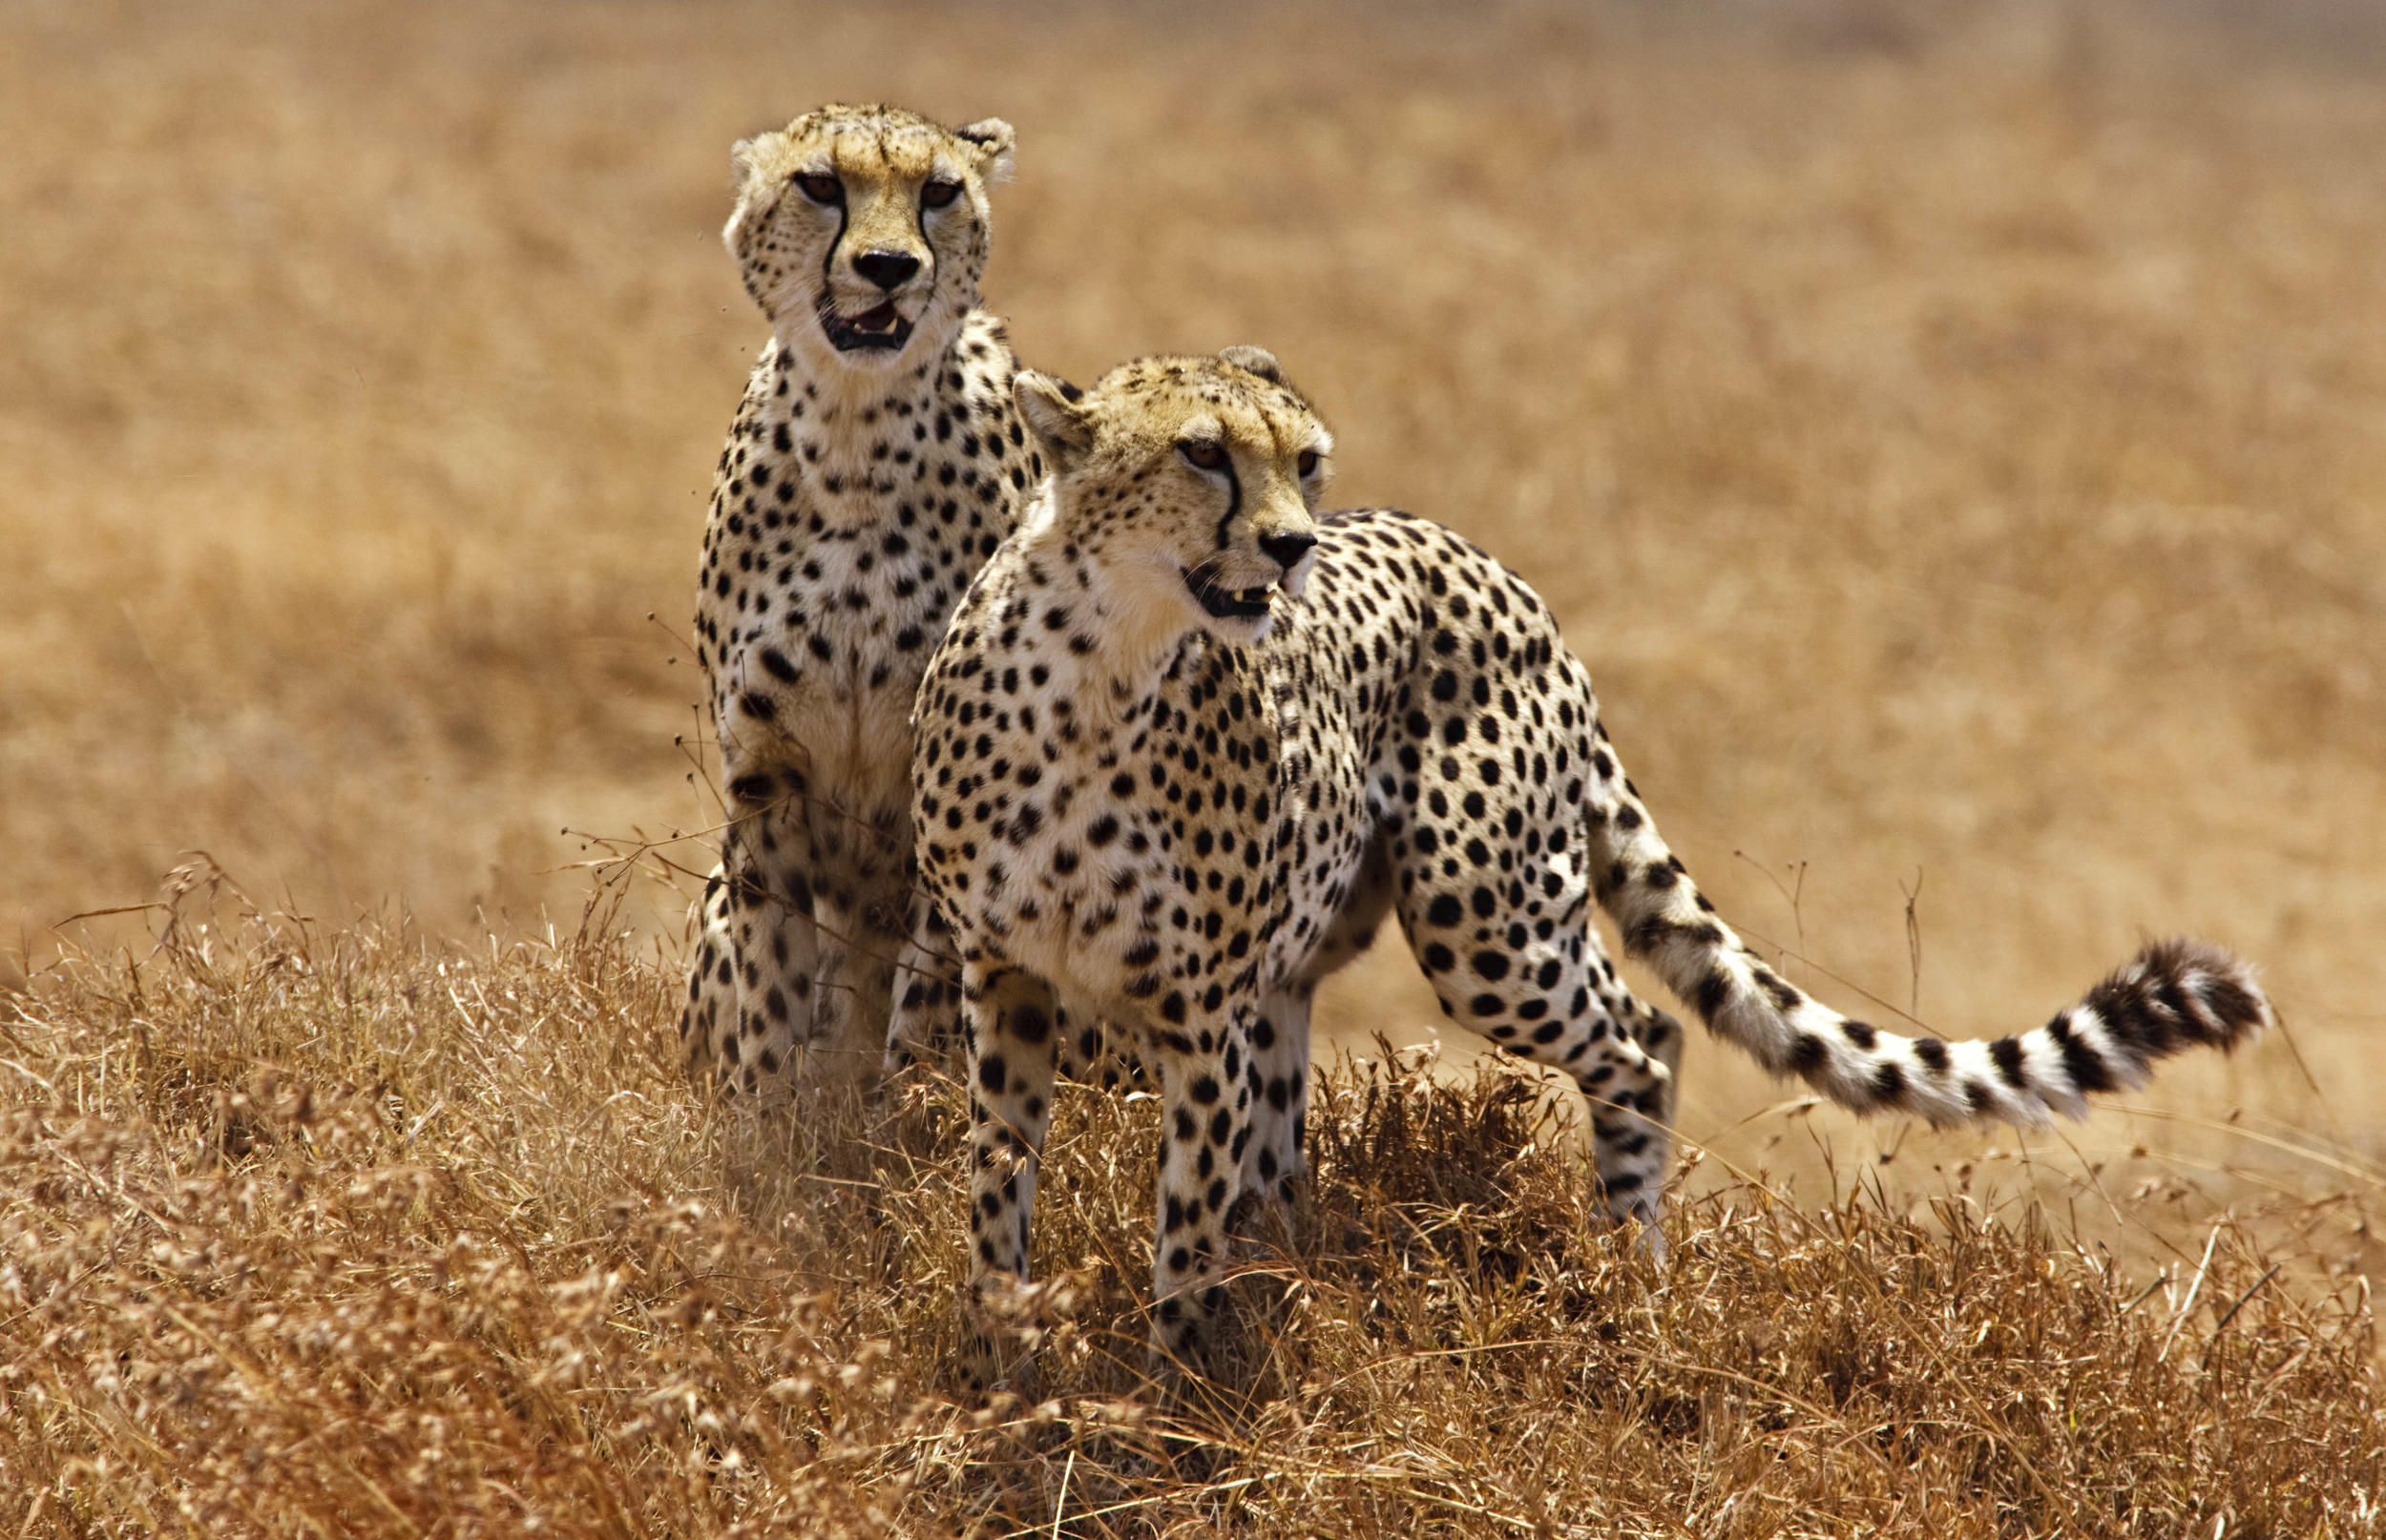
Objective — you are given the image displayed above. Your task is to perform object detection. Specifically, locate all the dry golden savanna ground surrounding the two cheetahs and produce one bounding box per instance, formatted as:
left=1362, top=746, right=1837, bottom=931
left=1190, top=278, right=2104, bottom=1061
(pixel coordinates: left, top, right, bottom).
left=0, top=0, right=2386, bottom=1535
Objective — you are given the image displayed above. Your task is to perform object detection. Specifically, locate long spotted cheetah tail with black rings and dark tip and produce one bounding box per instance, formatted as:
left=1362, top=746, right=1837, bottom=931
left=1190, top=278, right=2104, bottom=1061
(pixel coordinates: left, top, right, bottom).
left=1587, top=744, right=2271, bottom=1128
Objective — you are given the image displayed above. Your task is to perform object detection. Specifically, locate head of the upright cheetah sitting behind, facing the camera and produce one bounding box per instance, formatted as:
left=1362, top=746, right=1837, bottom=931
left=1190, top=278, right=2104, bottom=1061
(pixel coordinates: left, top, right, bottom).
left=721, top=105, right=1015, bottom=377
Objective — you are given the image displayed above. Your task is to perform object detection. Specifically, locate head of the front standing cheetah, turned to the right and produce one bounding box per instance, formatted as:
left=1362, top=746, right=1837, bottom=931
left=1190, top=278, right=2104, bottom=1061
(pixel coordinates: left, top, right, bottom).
left=1012, top=348, right=1334, bottom=644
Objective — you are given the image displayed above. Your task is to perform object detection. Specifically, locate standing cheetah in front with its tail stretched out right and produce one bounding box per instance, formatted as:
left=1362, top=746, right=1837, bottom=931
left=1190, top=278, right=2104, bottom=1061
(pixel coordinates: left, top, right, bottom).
left=911, top=348, right=2270, bottom=1371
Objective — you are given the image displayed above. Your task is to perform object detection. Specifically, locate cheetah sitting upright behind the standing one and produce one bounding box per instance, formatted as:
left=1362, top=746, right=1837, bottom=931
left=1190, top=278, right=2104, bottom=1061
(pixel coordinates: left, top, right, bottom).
left=680, top=105, right=1045, bottom=1099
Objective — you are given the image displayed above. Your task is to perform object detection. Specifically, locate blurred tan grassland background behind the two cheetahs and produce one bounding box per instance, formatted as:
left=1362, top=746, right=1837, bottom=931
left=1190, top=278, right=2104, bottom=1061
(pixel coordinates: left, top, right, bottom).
left=0, top=0, right=2386, bottom=1261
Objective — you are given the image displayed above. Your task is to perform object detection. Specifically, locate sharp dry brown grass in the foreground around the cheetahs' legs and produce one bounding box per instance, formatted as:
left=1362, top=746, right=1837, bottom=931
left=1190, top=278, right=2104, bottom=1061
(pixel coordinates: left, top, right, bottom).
left=0, top=894, right=2386, bottom=1540
